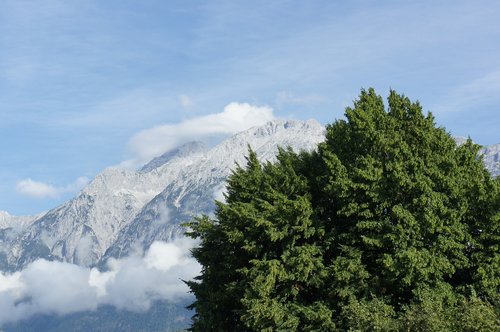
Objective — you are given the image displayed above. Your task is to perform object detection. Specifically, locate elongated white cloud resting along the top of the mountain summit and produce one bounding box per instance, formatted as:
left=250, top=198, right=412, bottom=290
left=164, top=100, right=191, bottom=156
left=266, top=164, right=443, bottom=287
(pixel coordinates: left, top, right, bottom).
left=122, top=103, right=274, bottom=167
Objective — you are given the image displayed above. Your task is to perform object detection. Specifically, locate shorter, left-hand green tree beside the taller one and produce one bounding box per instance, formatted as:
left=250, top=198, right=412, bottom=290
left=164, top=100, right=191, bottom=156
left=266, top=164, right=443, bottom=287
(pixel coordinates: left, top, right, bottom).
left=188, top=150, right=333, bottom=331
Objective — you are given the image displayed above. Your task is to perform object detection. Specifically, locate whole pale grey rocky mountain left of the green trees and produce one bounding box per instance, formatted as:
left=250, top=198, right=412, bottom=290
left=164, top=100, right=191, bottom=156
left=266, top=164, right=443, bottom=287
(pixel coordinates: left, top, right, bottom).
left=1, top=120, right=324, bottom=270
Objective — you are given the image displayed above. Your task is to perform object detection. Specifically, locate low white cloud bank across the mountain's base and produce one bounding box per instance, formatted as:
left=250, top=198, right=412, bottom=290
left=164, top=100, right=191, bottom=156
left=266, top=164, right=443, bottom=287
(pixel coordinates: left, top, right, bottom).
left=0, top=238, right=200, bottom=326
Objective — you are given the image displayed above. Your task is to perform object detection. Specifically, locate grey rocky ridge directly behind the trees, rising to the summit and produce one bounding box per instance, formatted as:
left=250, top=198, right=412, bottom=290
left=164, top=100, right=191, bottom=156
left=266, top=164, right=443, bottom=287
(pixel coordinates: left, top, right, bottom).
left=106, top=120, right=324, bottom=258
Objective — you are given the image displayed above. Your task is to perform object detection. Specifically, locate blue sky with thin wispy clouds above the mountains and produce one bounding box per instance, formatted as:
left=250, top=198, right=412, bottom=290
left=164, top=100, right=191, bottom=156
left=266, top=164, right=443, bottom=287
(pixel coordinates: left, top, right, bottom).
left=0, top=0, right=500, bottom=214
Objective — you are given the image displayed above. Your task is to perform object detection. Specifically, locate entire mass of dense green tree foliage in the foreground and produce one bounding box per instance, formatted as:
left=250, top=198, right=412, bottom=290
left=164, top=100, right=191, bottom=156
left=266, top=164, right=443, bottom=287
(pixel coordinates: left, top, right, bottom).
left=188, top=89, right=500, bottom=331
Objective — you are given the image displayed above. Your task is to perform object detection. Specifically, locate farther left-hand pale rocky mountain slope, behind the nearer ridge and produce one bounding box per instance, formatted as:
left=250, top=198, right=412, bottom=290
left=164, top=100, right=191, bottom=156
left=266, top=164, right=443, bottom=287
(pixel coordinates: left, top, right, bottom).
left=7, top=141, right=207, bottom=270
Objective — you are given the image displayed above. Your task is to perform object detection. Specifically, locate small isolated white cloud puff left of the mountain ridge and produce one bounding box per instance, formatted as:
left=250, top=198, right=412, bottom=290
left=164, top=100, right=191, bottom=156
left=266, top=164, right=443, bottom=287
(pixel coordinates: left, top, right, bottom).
left=16, top=177, right=89, bottom=198
